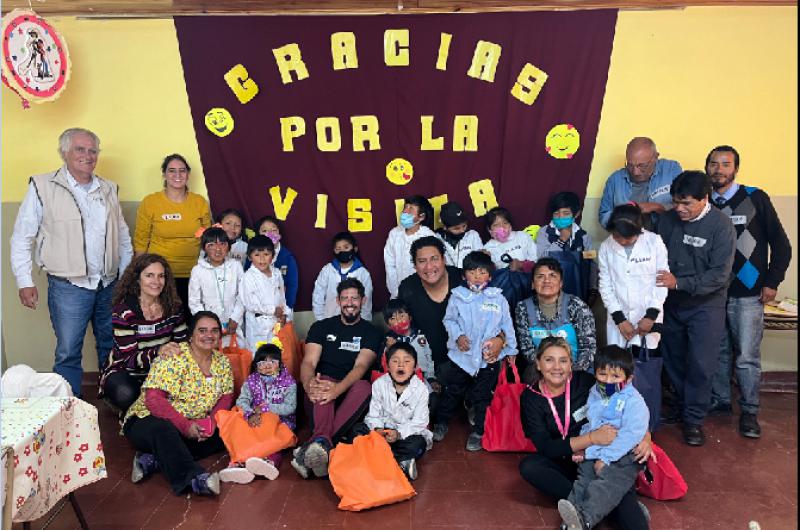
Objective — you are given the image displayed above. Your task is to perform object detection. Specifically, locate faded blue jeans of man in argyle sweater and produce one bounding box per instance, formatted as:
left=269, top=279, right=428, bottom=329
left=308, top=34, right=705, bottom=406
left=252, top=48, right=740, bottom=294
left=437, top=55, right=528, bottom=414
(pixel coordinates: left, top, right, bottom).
left=711, top=296, right=764, bottom=414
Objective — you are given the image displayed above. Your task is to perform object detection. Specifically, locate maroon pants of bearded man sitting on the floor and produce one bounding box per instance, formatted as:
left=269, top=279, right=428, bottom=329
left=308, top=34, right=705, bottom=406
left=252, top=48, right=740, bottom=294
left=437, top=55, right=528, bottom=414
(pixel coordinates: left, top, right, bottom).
left=305, top=375, right=372, bottom=445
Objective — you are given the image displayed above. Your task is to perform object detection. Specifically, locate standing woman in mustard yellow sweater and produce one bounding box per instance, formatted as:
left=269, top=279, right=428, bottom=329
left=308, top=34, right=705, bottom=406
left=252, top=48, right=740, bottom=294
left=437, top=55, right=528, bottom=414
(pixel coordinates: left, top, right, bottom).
left=133, top=154, right=211, bottom=311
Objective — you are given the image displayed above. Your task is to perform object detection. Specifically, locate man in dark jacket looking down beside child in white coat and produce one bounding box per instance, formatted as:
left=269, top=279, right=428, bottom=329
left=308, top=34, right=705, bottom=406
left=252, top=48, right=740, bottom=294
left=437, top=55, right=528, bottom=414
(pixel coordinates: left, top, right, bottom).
left=656, top=171, right=736, bottom=446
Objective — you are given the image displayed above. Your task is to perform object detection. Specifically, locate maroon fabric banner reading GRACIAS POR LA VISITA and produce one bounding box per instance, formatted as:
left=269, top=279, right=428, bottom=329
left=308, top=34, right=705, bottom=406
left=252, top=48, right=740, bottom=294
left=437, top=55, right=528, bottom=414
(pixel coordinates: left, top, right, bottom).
left=175, top=10, right=617, bottom=310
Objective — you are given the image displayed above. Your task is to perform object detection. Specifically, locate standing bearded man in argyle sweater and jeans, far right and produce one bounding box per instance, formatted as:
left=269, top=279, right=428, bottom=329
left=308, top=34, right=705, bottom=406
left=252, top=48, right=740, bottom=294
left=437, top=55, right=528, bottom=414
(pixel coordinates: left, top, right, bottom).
left=706, top=145, right=792, bottom=438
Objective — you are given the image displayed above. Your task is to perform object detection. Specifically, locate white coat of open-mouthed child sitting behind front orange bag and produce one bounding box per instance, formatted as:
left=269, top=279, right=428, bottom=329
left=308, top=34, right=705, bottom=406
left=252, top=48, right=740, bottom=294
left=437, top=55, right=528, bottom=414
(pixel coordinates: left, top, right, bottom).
left=364, top=374, right=433, bottom=449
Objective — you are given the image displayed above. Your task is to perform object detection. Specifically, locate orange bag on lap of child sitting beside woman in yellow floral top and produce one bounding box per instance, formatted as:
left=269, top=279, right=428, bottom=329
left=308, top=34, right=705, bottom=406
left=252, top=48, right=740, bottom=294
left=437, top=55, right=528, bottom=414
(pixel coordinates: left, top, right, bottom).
left=214, top=407, right=297, bottom=462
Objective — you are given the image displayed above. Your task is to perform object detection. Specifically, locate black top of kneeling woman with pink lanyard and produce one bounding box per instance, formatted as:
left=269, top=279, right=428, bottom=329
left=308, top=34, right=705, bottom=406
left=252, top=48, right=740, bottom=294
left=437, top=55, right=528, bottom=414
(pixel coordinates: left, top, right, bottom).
left=520, top=370, right=595, bottom=459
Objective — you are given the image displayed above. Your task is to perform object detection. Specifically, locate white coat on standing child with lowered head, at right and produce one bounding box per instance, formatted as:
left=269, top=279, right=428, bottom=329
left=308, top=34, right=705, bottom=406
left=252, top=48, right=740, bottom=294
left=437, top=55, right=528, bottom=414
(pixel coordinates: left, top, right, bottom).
left=598, top=230, right=669, bottom=349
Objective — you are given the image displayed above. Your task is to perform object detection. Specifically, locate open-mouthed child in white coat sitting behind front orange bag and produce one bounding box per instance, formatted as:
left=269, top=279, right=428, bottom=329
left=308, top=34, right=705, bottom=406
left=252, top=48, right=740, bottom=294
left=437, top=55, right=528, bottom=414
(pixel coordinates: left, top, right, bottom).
left=354, top=342, right=433, bottom=480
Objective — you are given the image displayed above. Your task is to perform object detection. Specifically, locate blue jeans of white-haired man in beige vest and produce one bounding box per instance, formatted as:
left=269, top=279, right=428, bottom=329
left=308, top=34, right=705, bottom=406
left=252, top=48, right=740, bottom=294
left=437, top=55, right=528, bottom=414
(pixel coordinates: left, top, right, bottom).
left=47, top=275, right=117, bottom=396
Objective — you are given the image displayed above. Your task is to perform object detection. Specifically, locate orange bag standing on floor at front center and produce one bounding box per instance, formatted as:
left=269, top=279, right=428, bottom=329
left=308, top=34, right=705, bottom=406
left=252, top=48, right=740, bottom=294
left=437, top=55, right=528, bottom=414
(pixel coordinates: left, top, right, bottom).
left=328, top=431, right=417, bottom=512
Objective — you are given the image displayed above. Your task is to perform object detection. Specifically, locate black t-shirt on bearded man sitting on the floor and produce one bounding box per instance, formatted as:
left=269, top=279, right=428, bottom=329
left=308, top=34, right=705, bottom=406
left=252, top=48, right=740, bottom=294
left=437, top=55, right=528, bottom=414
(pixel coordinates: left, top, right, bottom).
left=306, top=315, right=383, bottom=381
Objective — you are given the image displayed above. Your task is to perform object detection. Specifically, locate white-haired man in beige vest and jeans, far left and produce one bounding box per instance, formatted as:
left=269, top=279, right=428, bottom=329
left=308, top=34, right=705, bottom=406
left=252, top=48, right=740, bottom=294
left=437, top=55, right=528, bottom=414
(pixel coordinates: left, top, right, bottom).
left=11, top=128, right=133, bottom=396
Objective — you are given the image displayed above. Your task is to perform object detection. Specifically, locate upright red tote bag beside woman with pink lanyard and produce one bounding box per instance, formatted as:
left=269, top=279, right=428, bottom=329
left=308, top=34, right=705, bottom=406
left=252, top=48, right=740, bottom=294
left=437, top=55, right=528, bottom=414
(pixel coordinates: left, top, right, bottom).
left=482, top=359, right=536, bottom=453
